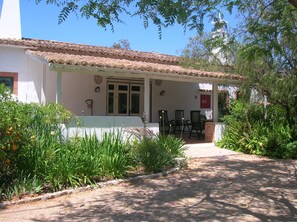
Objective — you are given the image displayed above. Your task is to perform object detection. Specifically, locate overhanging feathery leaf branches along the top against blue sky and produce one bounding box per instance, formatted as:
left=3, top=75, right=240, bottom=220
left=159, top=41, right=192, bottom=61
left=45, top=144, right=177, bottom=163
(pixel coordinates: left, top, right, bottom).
left=35, top=0, right=297, bottom=33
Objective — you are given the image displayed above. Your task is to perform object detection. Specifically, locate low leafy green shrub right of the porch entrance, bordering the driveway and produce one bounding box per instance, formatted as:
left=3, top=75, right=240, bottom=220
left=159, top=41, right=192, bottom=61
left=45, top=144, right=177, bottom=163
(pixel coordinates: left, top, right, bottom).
left=219, top=101, right=296, bottom=158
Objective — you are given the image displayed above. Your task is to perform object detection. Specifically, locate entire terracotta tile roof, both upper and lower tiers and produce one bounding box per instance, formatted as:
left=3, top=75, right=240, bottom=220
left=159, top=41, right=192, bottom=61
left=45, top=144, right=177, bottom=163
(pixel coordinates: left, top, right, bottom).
left=0, top=38, right=243, bottom=81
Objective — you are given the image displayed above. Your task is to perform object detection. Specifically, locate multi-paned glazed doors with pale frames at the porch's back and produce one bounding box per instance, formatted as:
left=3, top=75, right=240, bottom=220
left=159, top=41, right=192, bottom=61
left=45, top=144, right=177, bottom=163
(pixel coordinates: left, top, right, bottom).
left=107, top=82, right=143, bottom=116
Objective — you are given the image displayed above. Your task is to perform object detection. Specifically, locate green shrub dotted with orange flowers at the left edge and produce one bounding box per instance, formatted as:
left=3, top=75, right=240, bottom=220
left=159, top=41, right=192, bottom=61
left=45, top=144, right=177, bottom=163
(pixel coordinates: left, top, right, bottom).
left=0, top=93, right=31, bottom=184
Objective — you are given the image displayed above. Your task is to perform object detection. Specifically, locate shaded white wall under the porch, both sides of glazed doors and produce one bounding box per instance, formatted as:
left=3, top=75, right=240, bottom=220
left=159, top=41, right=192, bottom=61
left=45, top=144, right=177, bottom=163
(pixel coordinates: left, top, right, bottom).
left=57, top=76, right=212, bottom=123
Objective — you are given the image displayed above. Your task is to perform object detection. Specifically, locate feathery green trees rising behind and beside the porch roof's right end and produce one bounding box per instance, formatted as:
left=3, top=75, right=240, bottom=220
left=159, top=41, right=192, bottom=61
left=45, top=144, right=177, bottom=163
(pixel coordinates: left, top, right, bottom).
left=178, top=0, right=297, bottom=123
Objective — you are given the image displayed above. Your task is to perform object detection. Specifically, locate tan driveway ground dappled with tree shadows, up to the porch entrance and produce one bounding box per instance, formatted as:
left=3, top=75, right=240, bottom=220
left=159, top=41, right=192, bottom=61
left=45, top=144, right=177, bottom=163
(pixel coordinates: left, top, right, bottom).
left=0, top=145, right=297, bottom=221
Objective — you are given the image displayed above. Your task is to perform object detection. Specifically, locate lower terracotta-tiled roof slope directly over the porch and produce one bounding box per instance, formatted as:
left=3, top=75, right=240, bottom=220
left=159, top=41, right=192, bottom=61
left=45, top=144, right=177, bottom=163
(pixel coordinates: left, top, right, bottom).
left=27, top=47, right=244, bottom=82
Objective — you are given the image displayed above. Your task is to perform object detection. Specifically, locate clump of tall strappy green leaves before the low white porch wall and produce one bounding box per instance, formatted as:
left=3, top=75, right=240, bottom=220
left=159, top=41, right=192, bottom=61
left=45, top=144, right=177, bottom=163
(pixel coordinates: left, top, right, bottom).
left=33, top=133, right=132, bottom=190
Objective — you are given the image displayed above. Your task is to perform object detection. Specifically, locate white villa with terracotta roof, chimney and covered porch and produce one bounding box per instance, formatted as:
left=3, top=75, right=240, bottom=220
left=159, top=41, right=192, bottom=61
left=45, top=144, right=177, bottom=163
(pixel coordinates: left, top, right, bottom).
left=0, top=0, right=242, bottom=140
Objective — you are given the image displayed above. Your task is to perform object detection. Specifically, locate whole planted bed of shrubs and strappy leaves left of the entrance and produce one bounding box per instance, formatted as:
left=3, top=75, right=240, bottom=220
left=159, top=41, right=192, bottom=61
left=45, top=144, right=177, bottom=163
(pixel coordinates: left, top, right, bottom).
left=0, top=85, right=183, bottom=200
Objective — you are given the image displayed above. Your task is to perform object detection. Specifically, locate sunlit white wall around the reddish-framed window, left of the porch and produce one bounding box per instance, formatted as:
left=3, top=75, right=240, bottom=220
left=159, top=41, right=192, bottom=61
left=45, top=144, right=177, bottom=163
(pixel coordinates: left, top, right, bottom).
left=0, top=46, right=41, bottom=103
